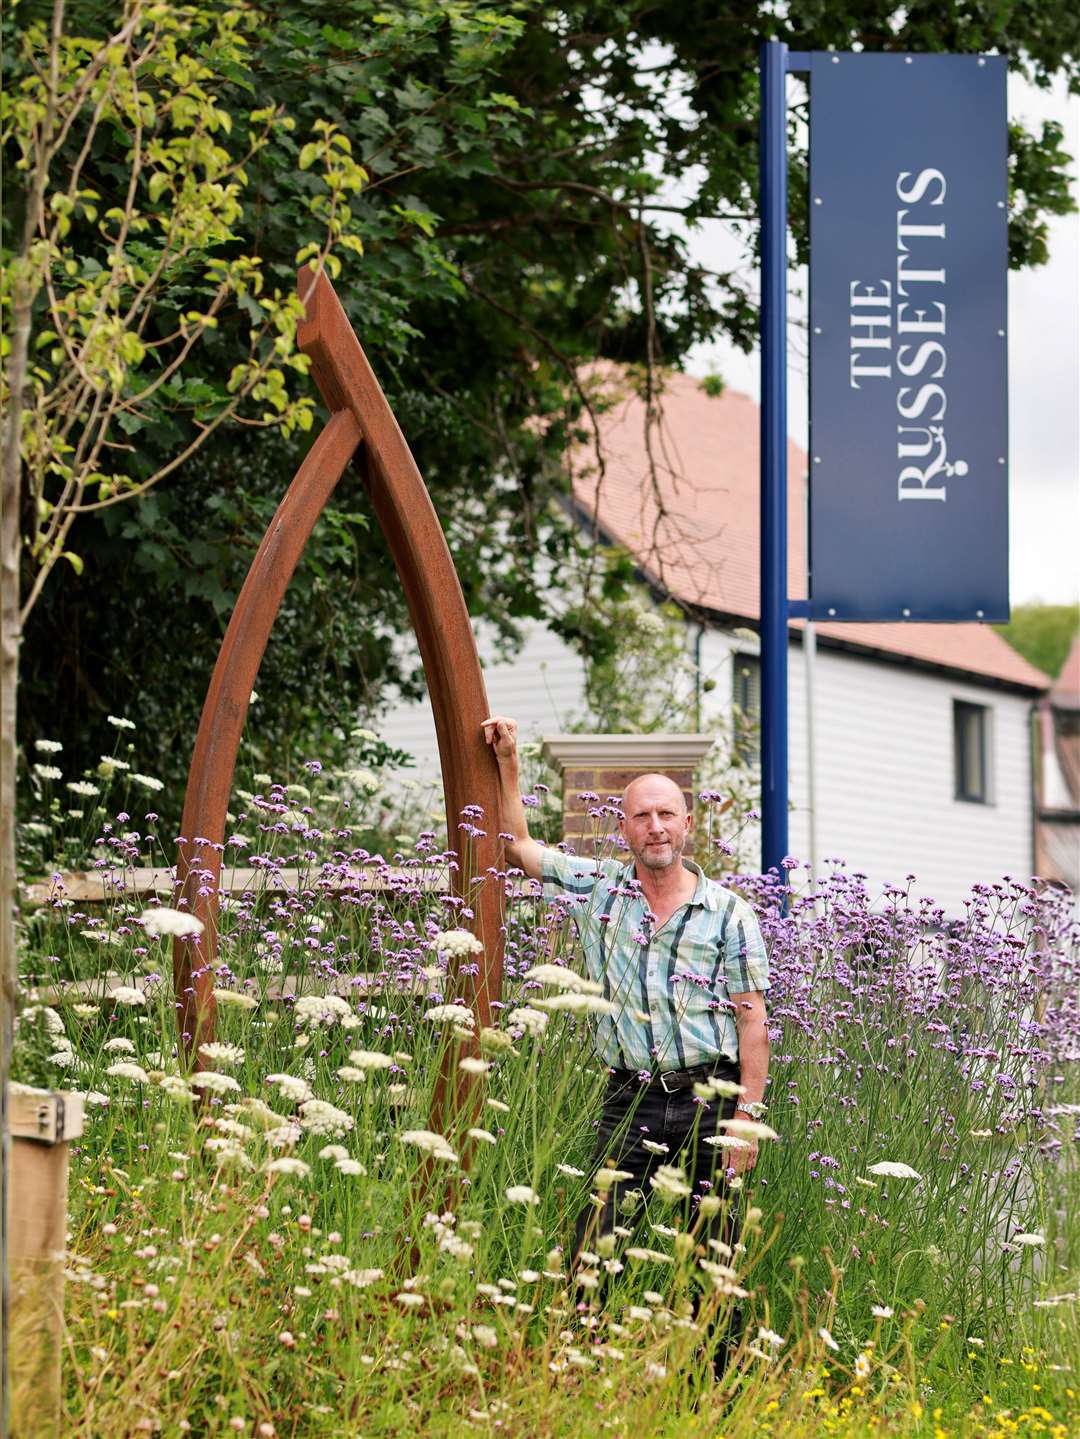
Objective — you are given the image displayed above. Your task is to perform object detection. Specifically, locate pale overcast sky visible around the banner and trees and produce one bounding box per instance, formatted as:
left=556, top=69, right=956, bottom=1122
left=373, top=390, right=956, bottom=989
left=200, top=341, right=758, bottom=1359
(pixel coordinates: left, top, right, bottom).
left=687, top=78, right=1080, bottom=604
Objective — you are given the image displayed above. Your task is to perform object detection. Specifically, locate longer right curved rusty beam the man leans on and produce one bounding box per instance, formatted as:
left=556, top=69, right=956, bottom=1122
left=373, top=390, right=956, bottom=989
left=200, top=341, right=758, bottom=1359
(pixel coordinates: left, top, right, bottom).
left=298, top=268, right=503, bottom=1132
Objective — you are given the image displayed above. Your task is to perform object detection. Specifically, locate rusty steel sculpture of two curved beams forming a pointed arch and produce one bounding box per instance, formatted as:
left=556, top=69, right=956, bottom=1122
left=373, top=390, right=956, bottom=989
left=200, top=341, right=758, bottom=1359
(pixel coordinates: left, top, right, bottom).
left=173, top=268, right=503, bottom=1124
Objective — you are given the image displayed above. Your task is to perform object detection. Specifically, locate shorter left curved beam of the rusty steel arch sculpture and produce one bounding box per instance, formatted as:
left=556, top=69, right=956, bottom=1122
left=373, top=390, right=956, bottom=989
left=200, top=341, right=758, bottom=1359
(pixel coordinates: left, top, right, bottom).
left=173, top=410, right=360, bottom=1063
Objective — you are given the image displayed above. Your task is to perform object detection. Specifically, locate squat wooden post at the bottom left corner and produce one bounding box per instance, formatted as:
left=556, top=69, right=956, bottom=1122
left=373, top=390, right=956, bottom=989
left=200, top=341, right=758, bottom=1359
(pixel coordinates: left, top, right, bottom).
left=6, top=1089, right=82, bottom=1439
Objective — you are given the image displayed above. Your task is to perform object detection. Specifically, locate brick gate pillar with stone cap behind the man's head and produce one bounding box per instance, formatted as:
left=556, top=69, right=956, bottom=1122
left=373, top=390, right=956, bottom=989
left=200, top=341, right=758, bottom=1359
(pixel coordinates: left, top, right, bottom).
left=541, top=734, right=716, bottom=852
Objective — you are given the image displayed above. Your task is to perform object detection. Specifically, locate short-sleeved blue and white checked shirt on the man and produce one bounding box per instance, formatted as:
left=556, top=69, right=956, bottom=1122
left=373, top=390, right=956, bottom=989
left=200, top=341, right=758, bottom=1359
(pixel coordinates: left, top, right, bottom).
left=541, top=849, right=769, bottom=1072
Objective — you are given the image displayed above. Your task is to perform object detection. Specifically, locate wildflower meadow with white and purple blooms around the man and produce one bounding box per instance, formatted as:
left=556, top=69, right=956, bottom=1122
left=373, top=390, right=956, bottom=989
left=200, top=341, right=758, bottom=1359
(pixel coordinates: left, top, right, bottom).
left=13, top=747, right=1080, bottom=1439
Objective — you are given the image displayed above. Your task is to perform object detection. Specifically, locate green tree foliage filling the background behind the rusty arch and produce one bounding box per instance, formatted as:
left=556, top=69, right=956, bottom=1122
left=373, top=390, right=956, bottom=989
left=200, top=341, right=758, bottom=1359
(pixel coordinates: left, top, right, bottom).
left=0, top=0, right=1080, bottom=800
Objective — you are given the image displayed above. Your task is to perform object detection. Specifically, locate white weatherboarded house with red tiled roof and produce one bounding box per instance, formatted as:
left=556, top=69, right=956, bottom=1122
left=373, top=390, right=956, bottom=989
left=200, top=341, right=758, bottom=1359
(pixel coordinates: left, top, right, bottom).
left=384, top=374, right=1048, bottom=914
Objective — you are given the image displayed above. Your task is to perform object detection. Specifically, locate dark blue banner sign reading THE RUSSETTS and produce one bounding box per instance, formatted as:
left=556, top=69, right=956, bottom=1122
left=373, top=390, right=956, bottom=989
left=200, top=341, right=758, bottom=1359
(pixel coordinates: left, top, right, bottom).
left=800, top=52, right=1008, bottom=620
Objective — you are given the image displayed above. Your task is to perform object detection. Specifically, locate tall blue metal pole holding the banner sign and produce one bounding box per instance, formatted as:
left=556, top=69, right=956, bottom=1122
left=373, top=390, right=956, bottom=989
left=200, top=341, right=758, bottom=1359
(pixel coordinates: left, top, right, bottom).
left=759, top=40, right=788, bottom=871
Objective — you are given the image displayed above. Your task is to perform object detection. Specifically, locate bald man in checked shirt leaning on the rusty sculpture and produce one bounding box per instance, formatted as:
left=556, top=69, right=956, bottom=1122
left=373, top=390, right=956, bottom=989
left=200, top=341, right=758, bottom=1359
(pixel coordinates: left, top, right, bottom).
left=483, top=715, right=769, bottom=1364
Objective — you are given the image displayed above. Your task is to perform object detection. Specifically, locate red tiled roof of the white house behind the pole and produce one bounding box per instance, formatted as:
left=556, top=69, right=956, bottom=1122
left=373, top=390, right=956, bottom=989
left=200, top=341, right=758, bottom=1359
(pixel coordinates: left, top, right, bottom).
left=574, top=366, right=1050, bottom=689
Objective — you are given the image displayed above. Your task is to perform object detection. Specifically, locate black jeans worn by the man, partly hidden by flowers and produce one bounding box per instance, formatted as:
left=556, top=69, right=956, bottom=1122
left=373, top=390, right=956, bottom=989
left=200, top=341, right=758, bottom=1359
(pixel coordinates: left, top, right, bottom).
left=574, top=1062, right=742, bottom=1373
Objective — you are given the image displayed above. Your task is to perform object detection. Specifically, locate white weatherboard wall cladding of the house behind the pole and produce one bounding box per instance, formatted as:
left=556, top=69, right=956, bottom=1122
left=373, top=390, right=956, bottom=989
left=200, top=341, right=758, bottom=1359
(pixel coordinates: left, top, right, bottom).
left=380, top=623, right=1033, bottom=915
